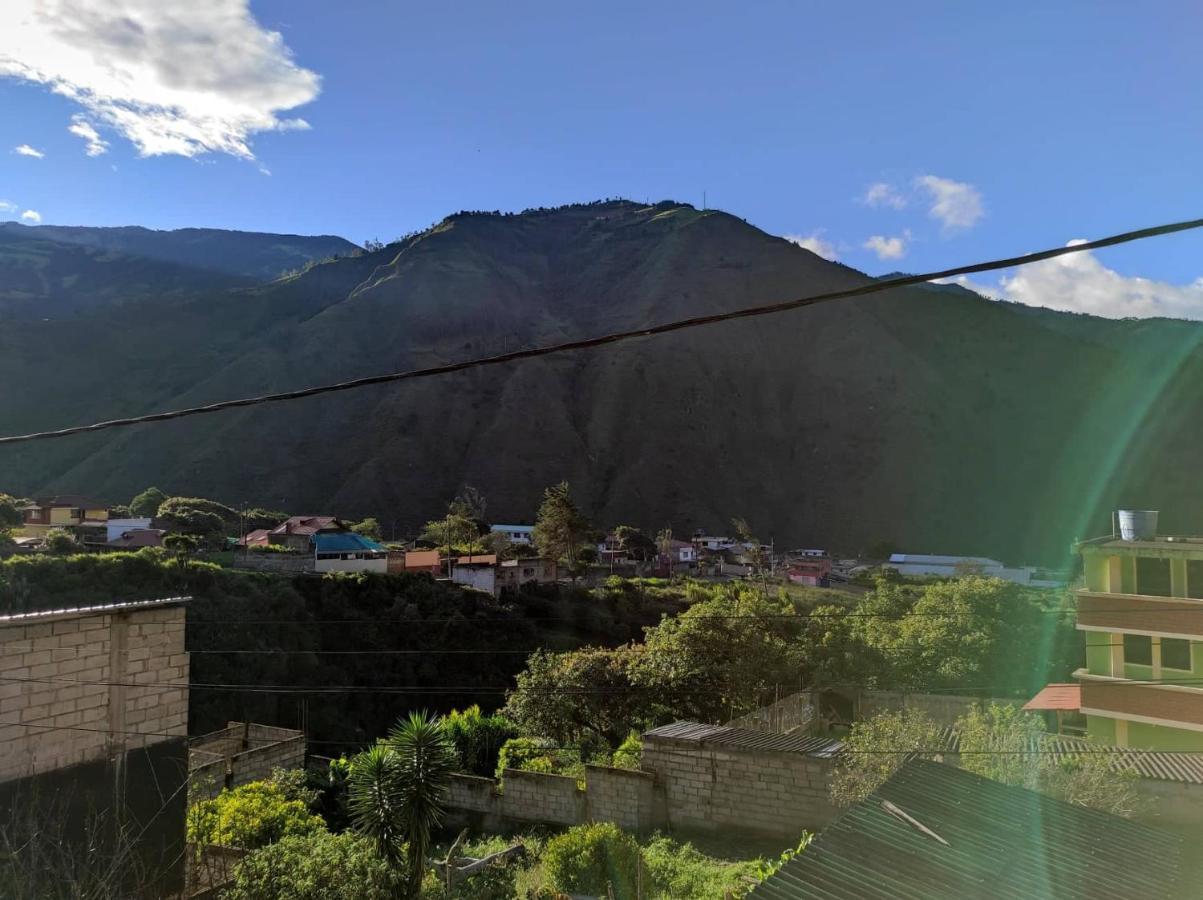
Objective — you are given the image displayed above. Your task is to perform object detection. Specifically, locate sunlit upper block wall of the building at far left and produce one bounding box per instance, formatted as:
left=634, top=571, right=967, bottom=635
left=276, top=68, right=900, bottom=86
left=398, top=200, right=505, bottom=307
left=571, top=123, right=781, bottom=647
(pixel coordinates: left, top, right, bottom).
left=0, top=603, right=189, bottom=781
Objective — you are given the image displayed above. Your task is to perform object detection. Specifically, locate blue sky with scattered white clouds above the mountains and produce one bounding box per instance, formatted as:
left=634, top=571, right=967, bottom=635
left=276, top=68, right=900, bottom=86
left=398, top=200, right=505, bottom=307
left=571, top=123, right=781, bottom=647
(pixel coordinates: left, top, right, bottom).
left=0, top=0, right=1203, bottom=319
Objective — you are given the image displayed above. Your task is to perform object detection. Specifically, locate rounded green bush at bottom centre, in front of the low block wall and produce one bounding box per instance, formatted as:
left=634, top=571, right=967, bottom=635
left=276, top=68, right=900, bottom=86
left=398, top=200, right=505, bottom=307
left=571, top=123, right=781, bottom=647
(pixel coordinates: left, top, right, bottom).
left=543, top=822, right=642, bottom=898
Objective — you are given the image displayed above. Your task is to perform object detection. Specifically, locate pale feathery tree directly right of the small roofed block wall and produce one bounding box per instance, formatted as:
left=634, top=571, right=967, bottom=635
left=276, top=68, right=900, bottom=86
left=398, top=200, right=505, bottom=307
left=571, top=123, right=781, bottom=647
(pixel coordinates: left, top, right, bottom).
left=831, top=709, right=941, bottom=806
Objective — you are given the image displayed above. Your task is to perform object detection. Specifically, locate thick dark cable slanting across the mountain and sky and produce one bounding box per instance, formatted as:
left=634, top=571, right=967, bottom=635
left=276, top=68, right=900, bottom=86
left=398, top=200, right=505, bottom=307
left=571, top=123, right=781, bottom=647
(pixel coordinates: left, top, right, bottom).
left=0, top=219, right=1203, bottom=444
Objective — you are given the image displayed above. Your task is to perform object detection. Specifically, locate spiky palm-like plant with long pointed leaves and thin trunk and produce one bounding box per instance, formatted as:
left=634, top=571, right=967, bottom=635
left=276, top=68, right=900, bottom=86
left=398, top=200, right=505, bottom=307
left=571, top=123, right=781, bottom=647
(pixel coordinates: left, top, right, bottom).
left=349, top=712, right=456, bottom=896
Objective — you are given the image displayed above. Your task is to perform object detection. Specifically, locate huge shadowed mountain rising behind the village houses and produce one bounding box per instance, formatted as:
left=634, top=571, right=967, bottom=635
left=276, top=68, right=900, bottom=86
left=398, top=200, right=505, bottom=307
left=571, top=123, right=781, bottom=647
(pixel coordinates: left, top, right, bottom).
left=0, top=201, right=1203, bottom=564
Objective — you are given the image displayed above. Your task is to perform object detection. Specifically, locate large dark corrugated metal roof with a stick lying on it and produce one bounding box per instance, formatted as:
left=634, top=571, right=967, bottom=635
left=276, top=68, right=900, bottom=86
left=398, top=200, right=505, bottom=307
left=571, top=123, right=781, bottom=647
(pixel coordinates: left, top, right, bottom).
left=751, top=759, right=1190, bottom=900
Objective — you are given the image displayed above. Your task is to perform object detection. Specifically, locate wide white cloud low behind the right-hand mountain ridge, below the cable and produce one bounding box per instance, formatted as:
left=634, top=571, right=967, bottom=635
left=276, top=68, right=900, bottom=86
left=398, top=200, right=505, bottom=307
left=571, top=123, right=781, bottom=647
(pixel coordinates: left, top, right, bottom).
left=954, top=241, right=1203, bottom=320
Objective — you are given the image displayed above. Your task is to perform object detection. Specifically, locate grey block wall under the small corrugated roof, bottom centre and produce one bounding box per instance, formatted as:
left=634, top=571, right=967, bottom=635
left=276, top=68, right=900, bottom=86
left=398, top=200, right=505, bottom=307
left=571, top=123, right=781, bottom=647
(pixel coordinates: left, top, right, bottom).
left=641, top=735, right=835, bottom=837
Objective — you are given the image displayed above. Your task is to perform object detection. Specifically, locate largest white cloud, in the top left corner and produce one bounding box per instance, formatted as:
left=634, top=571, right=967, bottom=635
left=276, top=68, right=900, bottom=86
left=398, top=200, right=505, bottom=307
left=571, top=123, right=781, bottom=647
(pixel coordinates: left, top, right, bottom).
left=0, top=0, right=320, bottom=159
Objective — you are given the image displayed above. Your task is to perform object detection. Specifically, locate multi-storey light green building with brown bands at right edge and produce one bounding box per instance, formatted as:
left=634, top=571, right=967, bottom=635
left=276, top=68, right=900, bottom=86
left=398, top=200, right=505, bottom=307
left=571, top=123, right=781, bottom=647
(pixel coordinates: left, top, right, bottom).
left=1075, top=517, right=1203, bottom=751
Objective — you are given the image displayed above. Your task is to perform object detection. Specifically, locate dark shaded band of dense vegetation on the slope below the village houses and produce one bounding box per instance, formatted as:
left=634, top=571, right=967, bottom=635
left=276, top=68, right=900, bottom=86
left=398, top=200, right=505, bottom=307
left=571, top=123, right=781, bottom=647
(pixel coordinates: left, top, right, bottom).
left=0, top=550, right=682, bottom=741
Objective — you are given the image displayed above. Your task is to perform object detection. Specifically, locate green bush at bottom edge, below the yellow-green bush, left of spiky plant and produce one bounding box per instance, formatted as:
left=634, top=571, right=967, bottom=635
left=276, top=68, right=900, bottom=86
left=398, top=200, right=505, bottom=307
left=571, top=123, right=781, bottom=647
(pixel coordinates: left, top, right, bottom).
left=221, top=831, right=403, bottom=900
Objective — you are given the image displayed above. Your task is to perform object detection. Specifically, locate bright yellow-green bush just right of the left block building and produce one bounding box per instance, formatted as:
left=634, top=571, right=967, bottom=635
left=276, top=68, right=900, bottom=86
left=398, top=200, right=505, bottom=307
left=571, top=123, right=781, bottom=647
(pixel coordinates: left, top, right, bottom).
left=188, top=781, right=326, bottom=849
